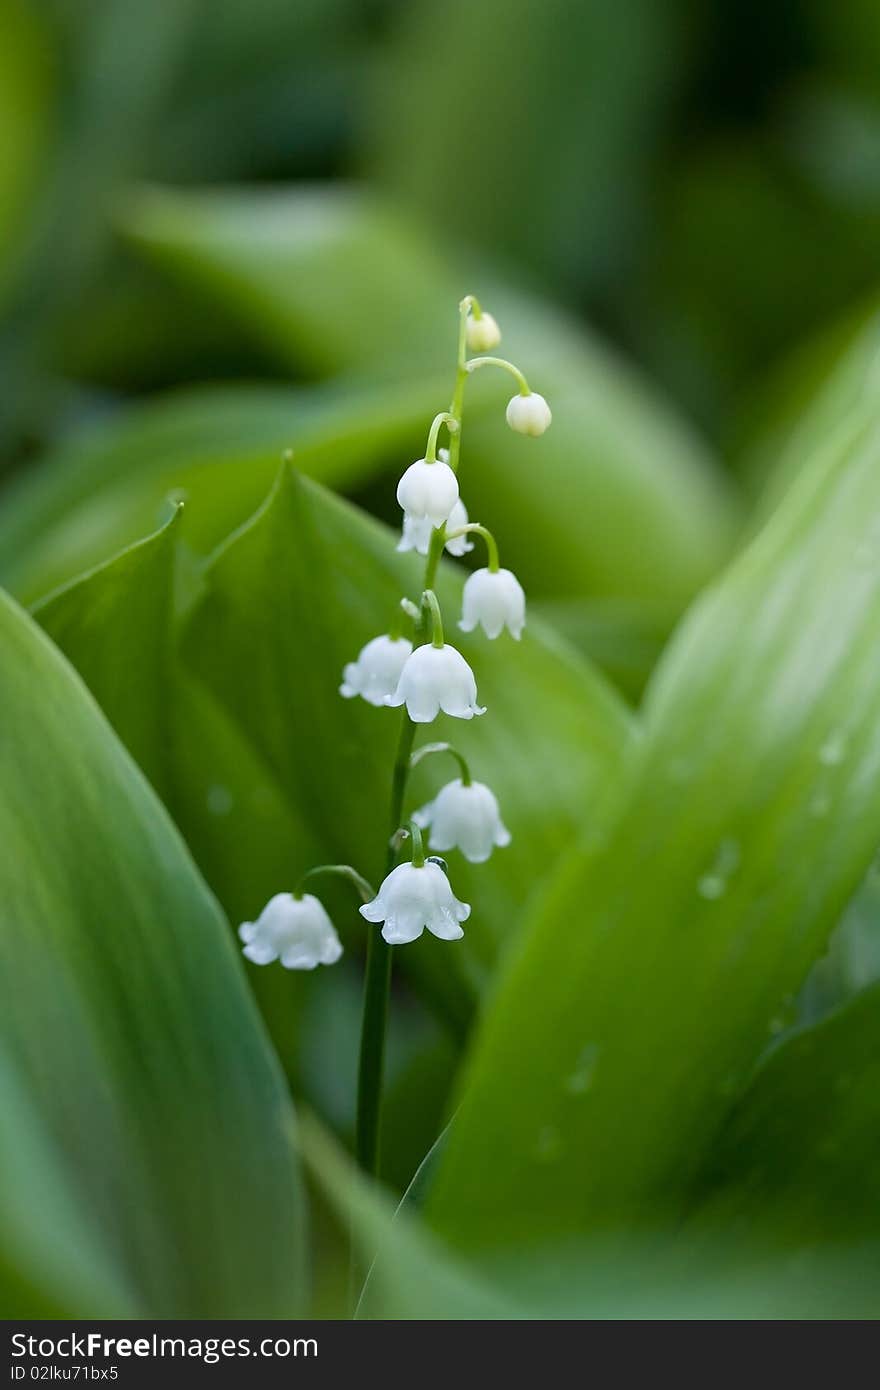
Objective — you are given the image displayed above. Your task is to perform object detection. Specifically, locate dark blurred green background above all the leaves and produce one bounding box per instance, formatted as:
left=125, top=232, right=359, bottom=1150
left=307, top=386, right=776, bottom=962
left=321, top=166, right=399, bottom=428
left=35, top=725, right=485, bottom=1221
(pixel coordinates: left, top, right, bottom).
left=0, top=0, right=880, bottom=455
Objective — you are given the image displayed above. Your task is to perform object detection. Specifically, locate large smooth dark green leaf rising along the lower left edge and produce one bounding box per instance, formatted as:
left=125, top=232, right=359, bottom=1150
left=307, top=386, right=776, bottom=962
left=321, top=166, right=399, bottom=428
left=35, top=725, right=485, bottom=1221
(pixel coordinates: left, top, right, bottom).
left=0, top=599, right=303, bottom=1318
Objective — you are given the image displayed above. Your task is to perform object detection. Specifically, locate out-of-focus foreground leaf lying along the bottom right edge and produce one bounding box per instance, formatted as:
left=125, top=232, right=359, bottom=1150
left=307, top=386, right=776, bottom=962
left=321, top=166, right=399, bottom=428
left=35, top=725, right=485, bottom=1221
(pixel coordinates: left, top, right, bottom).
left=319, top=1120, right=880, bottom=1319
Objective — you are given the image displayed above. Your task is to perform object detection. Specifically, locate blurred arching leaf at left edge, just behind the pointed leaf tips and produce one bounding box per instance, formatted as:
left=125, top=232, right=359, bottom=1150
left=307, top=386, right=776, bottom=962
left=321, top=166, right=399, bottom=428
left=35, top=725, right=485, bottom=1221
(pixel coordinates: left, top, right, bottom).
left=0, top=381, right=434, bottom=600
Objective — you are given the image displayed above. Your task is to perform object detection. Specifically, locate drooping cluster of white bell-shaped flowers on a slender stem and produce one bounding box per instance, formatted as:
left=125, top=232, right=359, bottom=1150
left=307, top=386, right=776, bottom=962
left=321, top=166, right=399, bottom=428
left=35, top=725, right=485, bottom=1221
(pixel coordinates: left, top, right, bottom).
left=239, top=296, right=552, bottom=969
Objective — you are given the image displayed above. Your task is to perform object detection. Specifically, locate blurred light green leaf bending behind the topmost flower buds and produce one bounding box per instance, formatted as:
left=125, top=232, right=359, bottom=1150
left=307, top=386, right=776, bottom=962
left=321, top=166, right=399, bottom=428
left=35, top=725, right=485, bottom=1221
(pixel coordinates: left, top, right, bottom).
left=124, top=186, right=737, bottom=607
